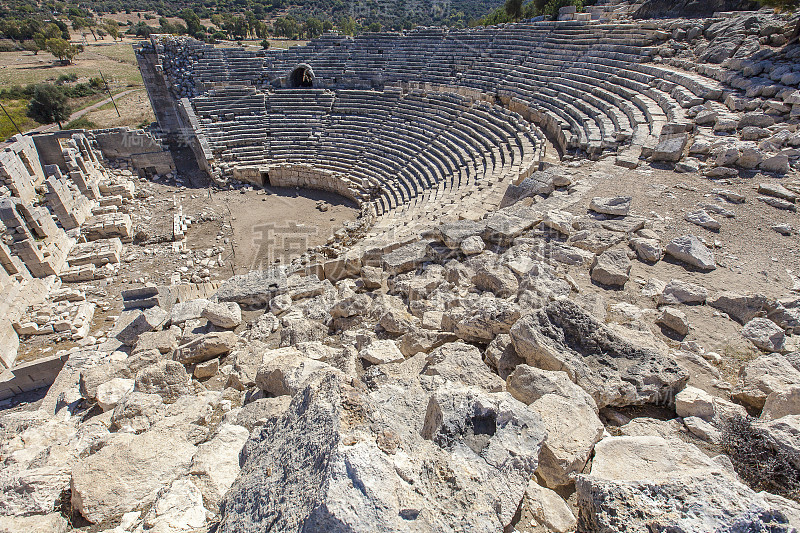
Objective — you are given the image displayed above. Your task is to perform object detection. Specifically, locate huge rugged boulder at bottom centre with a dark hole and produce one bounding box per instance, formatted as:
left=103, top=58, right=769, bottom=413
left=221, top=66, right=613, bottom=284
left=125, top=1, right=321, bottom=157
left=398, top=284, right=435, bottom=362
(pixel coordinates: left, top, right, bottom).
left=218, top=374, right=544, bottom=533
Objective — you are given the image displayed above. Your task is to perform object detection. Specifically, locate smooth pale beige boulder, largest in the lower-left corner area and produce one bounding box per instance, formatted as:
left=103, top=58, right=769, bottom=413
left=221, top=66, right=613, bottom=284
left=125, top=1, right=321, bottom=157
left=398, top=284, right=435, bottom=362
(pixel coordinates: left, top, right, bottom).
left=70, top=430, right=195, bottom=524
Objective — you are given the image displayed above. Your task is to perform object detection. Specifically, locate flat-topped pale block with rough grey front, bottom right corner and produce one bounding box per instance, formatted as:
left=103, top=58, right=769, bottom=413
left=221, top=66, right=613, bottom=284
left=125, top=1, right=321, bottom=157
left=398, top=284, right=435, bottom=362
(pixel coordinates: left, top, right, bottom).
left=576, top=436, right=793, bottom=533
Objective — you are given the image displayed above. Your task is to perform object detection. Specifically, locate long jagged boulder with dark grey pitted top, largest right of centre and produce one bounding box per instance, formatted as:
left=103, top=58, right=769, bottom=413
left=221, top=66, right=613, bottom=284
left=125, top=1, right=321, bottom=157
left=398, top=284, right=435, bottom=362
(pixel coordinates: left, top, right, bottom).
left=511, top=299, right=689, bottom=408
